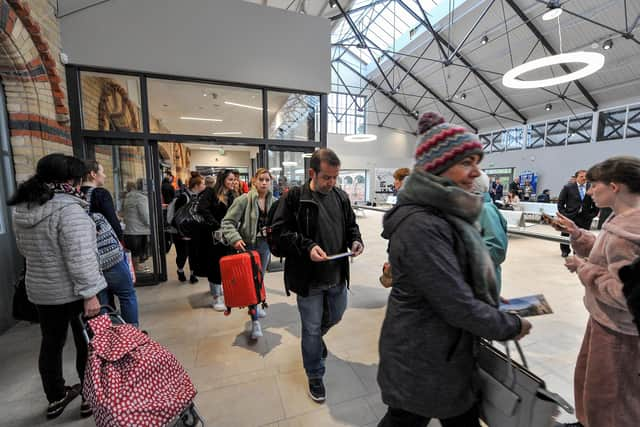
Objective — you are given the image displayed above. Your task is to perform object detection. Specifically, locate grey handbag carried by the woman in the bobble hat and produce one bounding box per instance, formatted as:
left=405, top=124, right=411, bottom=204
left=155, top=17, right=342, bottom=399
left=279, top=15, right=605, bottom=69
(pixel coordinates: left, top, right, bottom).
left=477, top=340, right=573, bottom=427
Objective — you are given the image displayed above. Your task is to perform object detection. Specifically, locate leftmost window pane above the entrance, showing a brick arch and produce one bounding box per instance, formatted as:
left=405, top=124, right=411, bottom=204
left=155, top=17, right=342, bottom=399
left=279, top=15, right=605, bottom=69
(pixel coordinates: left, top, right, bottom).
left=80, top=71, right=142, bottom=132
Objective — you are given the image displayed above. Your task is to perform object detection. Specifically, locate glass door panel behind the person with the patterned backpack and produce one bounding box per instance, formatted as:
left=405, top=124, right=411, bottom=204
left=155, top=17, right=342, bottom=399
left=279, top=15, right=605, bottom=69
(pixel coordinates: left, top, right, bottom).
left=87, top=139, right=166, bottom=286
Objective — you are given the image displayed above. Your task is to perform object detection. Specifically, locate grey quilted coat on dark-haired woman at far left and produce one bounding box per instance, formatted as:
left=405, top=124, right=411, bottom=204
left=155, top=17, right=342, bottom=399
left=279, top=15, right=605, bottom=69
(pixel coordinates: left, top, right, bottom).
left=13, top=194, right=107, bottom=305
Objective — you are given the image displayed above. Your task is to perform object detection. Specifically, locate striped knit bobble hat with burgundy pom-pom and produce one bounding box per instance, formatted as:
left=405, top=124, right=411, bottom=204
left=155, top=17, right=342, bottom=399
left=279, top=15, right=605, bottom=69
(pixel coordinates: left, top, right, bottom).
left=415, top=112, right=483, bottom=175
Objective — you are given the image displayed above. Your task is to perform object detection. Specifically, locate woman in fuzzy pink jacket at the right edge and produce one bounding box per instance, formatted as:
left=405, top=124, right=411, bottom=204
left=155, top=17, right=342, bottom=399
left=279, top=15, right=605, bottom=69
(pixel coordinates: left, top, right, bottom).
left=554, top=157, right=640, bottom=427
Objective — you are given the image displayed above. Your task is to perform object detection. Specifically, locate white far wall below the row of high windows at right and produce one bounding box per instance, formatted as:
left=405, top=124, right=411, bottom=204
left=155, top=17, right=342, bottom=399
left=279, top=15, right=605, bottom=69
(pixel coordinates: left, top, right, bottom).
left=482, top=138, right=640, bottom=196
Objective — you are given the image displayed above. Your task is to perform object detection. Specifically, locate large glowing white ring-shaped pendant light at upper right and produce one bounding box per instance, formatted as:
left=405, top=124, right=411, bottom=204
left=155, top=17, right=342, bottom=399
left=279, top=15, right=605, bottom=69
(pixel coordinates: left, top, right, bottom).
left=502, top=52, right=604, bottom=89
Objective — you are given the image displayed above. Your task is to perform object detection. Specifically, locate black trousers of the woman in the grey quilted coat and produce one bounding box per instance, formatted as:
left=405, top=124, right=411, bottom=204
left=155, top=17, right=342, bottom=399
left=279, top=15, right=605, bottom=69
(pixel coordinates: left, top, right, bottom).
left=37, top=300, right=88, bottom=402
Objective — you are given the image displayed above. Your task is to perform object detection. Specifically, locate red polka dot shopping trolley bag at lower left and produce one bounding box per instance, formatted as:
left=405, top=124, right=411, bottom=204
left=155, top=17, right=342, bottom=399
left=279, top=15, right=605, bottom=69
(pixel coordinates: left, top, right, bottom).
left=83, top=314, right=196, bottom=427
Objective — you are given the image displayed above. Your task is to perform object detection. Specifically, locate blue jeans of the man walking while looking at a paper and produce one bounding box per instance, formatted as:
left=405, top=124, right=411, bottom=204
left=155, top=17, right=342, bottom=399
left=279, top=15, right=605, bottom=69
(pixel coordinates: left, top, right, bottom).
left=297, top=284, right=347, bottom=379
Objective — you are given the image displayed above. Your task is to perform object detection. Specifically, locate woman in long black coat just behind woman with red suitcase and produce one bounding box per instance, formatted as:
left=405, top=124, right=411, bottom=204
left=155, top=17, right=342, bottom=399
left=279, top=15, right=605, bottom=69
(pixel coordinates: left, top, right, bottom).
left=193, top=169, right=238, bottom=311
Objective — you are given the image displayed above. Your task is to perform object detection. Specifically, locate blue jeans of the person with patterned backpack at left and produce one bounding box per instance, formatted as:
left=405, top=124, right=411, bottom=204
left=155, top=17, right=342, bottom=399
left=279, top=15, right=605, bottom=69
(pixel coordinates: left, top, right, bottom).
left=98, top=258, right=138, bottom=326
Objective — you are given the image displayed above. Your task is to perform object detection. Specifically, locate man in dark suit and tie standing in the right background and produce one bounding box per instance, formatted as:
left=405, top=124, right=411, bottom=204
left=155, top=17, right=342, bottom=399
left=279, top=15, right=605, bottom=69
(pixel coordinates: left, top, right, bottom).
left=558, top=170, right=598, bottom=258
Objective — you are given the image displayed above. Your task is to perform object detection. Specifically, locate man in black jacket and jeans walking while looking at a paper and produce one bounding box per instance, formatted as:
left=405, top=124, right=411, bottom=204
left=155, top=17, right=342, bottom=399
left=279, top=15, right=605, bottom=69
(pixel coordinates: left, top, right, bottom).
left=272, top=148, right=364, bottom=402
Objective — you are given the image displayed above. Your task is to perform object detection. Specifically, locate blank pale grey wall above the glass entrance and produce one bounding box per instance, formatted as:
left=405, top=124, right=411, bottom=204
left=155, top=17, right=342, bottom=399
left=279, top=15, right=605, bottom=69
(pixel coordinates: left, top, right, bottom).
left=60, top=0, right=331, bottom=92
